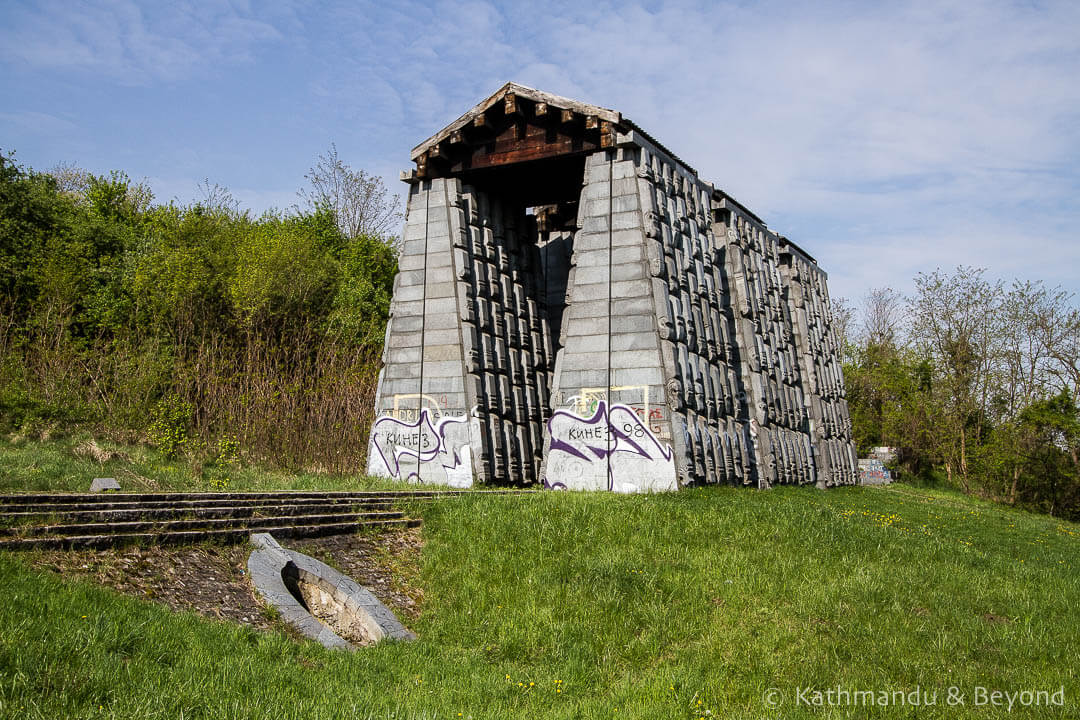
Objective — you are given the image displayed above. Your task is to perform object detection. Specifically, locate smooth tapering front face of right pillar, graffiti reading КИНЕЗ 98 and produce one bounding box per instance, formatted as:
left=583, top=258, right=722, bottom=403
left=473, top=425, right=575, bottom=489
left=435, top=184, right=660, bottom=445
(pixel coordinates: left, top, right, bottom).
left=543, top=150, right=678, bottom=492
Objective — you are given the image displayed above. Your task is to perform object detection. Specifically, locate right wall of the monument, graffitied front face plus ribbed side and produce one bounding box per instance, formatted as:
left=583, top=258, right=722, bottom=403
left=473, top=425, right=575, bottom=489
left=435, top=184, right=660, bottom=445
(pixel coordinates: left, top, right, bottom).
left=544, top=135, right=854, bottom=490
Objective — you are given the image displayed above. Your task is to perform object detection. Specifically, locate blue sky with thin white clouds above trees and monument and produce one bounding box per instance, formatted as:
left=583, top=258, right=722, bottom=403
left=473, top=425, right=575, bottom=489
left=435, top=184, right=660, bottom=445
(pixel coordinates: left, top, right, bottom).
left=0, top=0, right=1080, bottom=303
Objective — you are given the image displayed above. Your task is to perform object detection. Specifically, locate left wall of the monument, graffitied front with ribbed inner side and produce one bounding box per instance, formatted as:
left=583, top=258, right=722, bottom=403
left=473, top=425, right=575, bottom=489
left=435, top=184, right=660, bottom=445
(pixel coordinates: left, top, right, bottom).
left=368, top=179, right=553, bottom=487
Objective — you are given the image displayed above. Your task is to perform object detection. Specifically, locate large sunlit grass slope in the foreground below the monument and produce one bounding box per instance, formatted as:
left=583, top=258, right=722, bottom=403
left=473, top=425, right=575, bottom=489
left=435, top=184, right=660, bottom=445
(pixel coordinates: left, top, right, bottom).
left=0, top=486, right=1080, bottom=720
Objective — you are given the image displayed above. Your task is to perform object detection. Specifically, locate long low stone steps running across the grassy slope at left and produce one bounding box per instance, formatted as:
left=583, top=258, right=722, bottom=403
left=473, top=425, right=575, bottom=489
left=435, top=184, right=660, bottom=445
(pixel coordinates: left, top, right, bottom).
left=0, top=490, right=514, bottom=549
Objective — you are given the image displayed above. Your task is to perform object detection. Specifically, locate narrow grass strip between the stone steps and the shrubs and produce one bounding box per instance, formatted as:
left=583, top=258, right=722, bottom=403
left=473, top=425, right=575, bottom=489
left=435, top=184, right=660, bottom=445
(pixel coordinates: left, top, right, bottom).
left=0, top=435, right=415, bottom=492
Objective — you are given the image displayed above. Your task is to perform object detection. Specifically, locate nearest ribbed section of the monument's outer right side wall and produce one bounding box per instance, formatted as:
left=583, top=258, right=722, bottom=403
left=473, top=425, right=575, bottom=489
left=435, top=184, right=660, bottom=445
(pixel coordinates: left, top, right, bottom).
left=638, top=148, right=755, bottom=492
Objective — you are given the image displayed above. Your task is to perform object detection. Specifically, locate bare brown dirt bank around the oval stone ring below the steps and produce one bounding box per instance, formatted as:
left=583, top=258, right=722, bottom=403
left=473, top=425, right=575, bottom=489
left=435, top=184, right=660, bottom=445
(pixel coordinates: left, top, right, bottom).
left=27, top=528, right=423, bottom=629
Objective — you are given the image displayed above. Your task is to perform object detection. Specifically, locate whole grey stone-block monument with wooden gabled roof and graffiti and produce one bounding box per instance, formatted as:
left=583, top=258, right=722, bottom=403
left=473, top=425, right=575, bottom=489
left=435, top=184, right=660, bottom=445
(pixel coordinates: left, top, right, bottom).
left=368, top=83, right=858, bottom=492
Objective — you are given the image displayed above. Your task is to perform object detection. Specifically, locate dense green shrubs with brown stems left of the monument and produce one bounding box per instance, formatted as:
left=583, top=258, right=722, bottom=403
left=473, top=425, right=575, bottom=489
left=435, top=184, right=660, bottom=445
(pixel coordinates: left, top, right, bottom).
left=0, top=153, right=396, bottom=470
